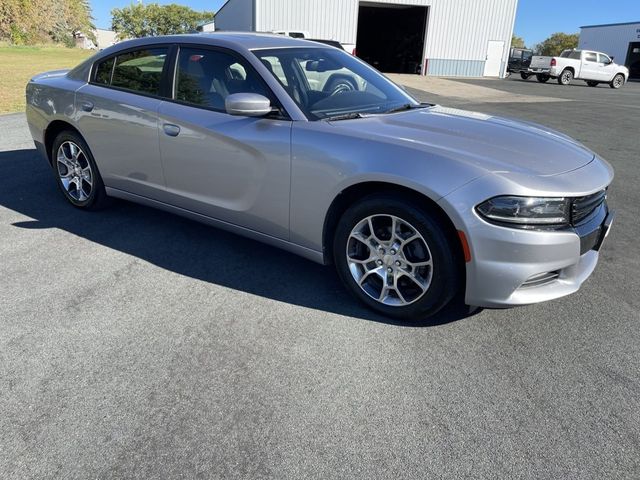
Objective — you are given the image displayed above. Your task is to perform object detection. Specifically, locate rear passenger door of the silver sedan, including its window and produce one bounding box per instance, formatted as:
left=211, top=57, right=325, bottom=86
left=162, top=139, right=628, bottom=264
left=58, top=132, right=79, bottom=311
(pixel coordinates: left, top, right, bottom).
left=76, top=45, right=169, bottom=198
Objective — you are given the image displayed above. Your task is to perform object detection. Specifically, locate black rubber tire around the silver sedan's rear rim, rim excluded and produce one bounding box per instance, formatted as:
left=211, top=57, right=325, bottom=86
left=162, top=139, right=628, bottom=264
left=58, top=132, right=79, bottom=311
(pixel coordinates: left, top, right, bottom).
left=51, top=130, right=109, bottom=210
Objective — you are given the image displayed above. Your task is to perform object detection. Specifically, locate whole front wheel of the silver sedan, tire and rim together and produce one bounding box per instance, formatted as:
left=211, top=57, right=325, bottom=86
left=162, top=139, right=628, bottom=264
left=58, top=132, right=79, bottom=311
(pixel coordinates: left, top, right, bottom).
left=333, top=195, right=460, bottom=320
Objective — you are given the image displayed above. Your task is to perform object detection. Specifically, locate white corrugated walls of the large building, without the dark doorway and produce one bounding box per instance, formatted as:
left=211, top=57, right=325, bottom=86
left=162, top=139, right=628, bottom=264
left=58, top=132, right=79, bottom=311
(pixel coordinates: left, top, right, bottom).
left=216, top=0, right=517, bottom=76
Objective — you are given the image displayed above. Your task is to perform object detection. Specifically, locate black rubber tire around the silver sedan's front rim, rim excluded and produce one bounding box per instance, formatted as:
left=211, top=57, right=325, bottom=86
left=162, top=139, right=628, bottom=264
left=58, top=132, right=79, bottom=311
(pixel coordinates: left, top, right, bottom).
left=333, top=194, right=462, bottom=321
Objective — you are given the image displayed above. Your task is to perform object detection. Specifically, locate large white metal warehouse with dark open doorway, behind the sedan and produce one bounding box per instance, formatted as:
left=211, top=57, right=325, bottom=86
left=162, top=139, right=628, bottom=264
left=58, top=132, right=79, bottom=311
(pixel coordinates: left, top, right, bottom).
left=215, top=0, right=517, bottom=77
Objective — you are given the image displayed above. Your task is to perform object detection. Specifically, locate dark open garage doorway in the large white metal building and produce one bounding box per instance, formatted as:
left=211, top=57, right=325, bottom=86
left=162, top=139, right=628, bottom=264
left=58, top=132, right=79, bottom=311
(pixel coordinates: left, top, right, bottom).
left=356, top=2, right=428, bottom=73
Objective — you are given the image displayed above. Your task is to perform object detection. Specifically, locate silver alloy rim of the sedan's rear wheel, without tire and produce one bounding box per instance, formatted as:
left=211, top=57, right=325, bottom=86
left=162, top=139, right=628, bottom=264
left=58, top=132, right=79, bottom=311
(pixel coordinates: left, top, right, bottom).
left=56, top=141, right=93, bottom=202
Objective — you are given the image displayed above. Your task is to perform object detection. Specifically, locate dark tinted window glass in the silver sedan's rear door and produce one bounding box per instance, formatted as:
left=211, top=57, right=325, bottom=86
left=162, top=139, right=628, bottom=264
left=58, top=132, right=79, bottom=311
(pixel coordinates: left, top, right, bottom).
left=111, top=48, right=167, bottom=95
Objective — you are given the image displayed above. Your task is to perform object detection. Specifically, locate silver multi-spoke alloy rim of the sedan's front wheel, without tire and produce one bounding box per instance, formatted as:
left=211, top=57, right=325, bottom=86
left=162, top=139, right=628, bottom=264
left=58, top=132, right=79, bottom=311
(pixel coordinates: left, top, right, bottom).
left=346, top=214, right=433, bottom=307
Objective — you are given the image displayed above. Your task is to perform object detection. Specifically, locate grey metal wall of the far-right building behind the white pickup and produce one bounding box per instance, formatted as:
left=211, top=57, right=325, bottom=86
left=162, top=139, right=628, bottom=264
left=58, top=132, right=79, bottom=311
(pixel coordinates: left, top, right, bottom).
left=580, top=23, right=640, bottom=65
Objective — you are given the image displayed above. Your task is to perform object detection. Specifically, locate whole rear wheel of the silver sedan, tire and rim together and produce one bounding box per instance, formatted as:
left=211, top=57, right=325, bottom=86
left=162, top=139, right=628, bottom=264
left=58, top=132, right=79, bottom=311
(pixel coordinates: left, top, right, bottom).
left=51, top=130, right=107, bottom=210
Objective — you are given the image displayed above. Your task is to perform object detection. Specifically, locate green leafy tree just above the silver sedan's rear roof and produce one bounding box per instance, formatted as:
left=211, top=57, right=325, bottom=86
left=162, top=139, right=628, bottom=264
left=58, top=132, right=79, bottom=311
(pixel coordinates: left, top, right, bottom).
left=111, top=3, right=213, bottom=38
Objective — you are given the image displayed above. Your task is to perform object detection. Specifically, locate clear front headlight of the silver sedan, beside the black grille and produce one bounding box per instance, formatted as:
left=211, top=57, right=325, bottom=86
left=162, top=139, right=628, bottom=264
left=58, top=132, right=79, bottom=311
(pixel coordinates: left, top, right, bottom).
left=476, top=196, right=571, bottom=228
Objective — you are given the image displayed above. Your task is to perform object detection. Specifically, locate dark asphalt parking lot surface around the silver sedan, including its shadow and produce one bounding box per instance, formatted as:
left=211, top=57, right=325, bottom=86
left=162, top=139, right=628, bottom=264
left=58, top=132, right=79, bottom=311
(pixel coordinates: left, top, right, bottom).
left=0, top=79, right=640, bottom=479
